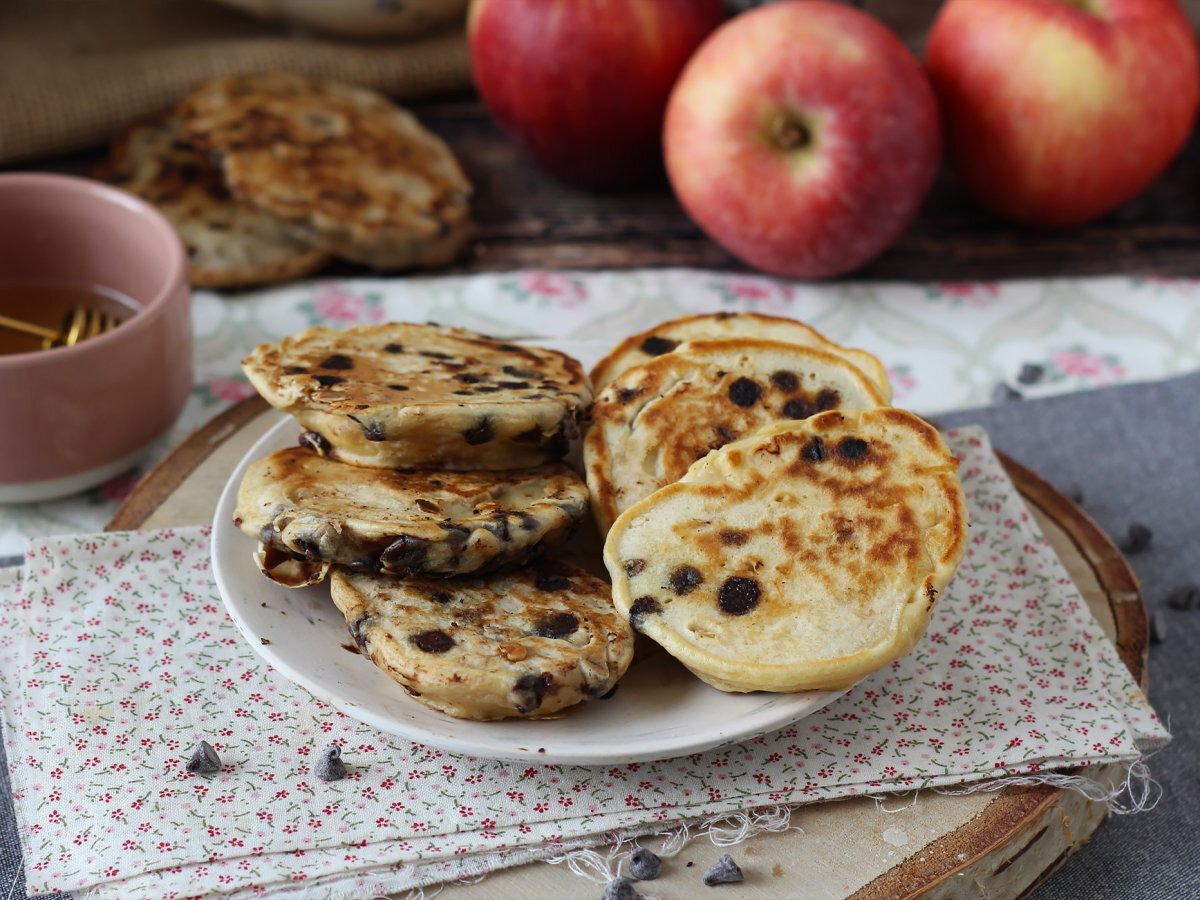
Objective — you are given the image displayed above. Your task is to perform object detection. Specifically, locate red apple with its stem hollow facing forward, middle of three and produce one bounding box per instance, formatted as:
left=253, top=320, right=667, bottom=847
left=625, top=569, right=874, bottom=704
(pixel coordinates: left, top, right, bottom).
left=664, top=0, right=942, bottom=278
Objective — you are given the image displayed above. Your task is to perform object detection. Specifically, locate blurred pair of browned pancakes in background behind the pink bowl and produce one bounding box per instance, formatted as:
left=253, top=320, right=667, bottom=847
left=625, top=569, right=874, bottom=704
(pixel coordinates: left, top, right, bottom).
left=96, top=72, right=472, bottom=288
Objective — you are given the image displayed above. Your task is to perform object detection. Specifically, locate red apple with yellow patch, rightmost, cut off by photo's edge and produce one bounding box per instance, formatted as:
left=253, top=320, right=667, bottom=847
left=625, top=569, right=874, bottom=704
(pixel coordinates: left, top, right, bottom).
left=925, top=0, right=1200, bottom=226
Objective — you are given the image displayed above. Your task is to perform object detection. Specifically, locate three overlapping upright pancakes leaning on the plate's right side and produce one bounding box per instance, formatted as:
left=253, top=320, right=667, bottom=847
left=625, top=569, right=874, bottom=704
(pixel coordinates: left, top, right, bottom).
left=584, top=313, right=967, bottom=691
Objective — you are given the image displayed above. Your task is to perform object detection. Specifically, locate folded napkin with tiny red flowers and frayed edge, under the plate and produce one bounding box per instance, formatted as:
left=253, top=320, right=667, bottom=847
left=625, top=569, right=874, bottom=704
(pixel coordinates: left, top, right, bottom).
left=0, top=428, right=1168, bottom=898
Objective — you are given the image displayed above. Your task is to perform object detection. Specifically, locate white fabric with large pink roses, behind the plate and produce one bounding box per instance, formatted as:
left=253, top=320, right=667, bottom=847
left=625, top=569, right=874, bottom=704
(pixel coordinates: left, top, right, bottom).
left=0, top=269, right=1200, bottom=556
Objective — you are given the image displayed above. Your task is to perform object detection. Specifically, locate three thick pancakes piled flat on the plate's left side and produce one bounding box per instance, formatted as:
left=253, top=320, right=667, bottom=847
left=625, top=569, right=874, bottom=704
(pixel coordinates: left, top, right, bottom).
left=228, top=324, right=632, bottom=719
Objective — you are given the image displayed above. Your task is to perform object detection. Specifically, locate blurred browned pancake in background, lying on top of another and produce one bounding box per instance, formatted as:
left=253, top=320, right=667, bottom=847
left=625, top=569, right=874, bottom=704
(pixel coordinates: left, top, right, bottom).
left=179, top=72, right=472, bottom=269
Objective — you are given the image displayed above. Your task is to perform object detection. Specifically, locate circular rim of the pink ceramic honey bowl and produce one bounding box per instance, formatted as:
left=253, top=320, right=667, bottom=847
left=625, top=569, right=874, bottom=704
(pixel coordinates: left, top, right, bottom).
left=0, top=172, right=190, bottom=372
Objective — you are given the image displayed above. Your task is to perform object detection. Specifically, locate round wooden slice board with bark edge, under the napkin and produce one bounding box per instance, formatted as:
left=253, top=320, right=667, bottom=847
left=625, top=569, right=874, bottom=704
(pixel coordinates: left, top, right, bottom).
left=108, top=397, right=1148, bottom=900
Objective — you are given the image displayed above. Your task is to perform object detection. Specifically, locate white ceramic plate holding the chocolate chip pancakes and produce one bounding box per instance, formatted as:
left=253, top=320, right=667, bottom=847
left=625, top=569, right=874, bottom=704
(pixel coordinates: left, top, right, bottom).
left=212, top=342, right=840, bottom=766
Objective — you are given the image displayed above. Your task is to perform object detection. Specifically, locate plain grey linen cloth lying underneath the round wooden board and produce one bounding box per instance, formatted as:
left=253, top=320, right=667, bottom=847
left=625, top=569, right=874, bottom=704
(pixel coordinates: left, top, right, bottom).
left=0, top=373, right=1200, bottom=900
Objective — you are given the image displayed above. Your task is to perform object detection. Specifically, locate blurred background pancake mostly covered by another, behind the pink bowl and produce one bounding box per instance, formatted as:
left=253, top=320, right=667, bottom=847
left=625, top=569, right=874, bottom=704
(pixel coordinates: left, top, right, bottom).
left=95, top=114, right=329, bottom=288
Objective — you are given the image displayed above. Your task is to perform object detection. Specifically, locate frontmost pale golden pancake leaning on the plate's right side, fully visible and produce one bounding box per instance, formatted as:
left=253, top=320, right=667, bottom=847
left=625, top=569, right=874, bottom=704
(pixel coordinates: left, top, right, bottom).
left=604, top=408, right=967, bottom=691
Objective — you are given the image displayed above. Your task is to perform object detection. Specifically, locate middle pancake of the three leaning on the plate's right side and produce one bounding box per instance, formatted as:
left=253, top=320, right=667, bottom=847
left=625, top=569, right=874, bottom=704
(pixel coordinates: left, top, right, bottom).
left=583, top=337, right=886, bottom=534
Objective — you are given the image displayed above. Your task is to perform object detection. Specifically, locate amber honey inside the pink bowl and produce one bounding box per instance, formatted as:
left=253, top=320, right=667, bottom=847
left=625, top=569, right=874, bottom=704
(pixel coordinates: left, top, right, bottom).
left=0, top=282, right=139, bottom=355
